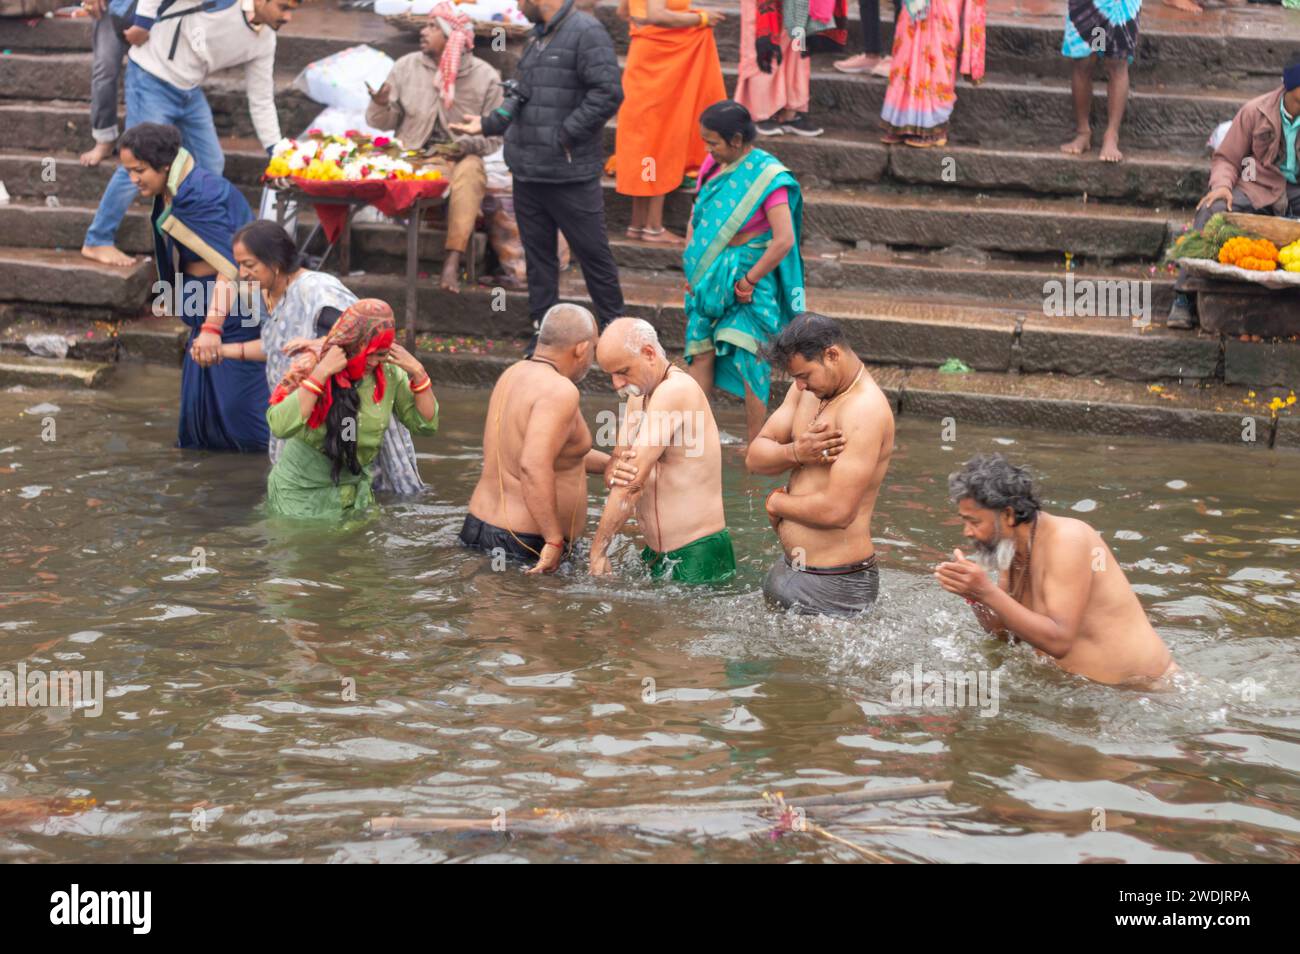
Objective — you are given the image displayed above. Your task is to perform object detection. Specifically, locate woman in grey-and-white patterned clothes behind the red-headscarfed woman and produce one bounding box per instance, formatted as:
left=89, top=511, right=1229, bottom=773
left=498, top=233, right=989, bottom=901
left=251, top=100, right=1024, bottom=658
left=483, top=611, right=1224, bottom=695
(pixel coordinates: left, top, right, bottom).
left=202, top=220, right=424, bottom=495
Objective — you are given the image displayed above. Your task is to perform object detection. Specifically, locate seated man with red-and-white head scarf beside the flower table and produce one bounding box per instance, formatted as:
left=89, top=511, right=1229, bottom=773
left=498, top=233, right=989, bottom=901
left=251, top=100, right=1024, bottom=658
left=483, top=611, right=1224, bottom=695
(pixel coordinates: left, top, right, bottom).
left=365, top=1, right=502, bottom=291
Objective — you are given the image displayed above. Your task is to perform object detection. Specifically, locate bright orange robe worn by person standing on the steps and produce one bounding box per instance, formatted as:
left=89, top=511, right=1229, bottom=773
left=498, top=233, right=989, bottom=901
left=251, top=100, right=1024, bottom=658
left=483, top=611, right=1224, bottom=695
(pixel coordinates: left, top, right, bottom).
left=614, top=0, right=727, bottom=196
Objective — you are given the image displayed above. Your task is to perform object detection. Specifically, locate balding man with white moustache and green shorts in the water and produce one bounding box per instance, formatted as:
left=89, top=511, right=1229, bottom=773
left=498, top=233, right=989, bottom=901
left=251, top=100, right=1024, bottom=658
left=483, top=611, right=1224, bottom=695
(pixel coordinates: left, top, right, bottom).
left=590, top=318, right=736, bottom=584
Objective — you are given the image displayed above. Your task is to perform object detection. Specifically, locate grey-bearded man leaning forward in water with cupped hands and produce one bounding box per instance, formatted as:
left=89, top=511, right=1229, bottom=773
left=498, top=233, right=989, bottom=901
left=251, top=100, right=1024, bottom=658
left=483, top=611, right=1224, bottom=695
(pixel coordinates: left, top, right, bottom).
left=935, top=454, right=1178, bottom=689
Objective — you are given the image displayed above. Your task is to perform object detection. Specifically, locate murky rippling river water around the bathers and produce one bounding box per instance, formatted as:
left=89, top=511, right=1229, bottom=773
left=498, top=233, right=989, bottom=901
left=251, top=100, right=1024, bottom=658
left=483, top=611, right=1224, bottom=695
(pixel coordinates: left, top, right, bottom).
left=0, top=369, right=1300, bottom=862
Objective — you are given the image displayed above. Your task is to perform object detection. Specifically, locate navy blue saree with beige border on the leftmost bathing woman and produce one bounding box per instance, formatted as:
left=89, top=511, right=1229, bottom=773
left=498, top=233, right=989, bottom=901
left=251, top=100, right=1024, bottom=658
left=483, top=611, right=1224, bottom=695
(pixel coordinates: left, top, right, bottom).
left=150, top=149, right=270, bottom=452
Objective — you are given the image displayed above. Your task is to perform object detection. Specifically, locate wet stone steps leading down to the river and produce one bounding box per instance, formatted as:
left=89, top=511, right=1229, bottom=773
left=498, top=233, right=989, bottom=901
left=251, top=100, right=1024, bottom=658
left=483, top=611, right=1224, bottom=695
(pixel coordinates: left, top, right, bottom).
left=0, top=0, right=1300, bottom=446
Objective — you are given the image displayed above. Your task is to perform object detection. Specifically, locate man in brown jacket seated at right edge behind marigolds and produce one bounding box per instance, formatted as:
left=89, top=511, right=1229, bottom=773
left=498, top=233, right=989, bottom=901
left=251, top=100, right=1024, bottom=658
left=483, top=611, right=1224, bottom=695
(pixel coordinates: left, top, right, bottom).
left=1165, top=56, right=1300, bottom=328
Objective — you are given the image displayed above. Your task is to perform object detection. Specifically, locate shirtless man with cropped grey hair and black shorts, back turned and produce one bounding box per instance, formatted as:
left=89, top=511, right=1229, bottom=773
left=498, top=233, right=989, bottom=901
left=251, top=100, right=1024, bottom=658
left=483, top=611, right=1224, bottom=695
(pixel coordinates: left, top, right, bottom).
left=460, top=303, right=636, bottom=573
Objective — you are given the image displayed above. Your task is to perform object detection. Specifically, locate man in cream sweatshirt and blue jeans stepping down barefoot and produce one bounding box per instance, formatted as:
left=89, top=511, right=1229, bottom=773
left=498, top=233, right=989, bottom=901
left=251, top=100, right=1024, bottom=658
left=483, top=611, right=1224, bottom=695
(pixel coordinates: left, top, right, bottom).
left=82, top=0, right=298, bottom=265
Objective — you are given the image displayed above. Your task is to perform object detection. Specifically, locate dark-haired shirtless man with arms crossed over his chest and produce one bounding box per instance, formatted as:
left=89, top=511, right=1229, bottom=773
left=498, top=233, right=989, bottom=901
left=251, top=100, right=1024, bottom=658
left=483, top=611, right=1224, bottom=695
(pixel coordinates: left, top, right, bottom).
left=745, top=312, right=893, bottom=616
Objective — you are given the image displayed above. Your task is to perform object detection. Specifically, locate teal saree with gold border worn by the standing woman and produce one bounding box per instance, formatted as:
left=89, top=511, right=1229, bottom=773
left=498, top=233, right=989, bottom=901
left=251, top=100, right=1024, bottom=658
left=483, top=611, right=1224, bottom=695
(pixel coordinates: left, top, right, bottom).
left=683, top=148, right=805, bottom=404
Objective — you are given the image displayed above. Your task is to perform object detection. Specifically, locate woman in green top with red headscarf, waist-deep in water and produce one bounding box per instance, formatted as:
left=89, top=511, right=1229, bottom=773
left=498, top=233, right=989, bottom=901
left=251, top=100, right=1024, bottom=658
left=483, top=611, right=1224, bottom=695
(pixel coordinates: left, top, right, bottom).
left=267, top=298, right=438, bottom=520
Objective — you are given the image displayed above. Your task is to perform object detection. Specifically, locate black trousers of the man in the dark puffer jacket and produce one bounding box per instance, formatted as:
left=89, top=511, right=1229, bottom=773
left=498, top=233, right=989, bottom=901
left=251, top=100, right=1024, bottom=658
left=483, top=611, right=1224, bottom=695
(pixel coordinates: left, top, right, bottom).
left=515, top=179, right=623, bottom=331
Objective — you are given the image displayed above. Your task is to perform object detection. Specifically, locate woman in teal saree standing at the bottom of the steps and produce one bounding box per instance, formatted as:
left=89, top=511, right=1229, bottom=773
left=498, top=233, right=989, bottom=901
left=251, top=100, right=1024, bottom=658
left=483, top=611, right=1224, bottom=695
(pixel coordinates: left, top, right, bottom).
left=684, top=99, right=806, bottom=442
